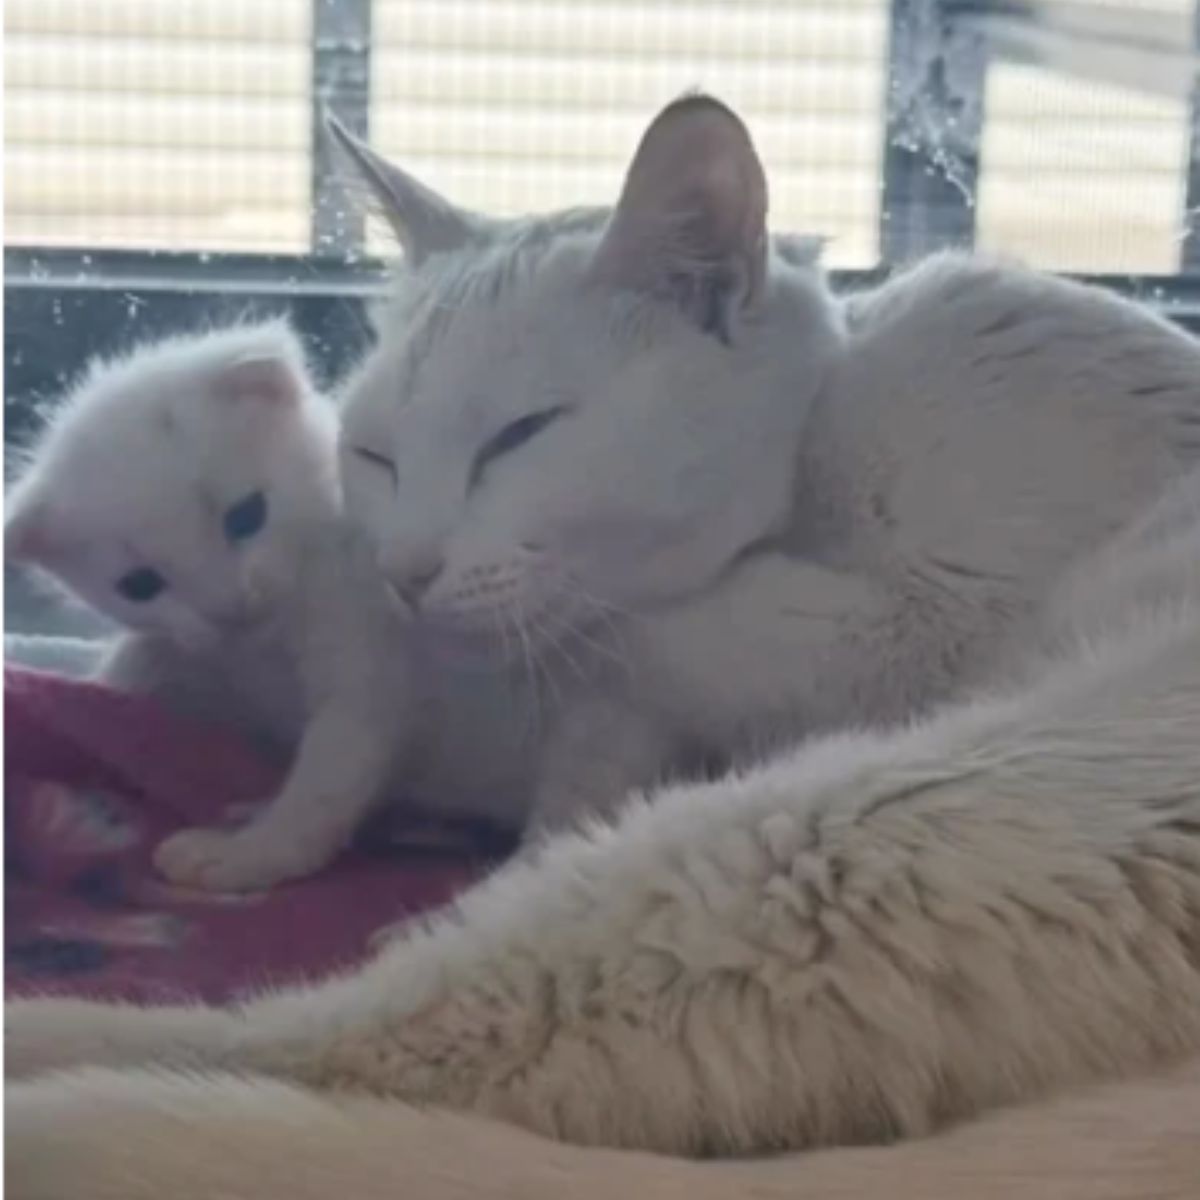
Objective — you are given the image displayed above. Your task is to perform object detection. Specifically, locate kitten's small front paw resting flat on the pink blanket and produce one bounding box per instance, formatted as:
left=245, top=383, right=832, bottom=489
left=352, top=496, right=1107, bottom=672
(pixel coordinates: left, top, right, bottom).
left=154, top=826, right=320, bottom=892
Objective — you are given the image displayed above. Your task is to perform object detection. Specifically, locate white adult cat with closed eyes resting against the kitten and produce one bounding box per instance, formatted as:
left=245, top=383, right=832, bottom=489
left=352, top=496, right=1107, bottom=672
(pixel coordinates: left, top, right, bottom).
left=340, top=97, right=1200, bottom=827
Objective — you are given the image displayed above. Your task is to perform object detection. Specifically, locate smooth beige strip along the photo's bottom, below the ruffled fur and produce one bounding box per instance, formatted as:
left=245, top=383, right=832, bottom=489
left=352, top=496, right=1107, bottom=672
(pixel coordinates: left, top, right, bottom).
left=5, top=1063, right=1200, bottom=1200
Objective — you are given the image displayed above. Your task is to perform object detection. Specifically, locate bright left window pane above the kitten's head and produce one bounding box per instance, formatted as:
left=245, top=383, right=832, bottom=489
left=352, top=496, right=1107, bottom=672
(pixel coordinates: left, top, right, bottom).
left=5, top=0, right=311, bottom=251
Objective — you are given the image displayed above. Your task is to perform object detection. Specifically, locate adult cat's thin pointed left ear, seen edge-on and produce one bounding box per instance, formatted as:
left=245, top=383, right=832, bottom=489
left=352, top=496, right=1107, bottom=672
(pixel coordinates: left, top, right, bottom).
left=325, top=115, right=485, bottom=263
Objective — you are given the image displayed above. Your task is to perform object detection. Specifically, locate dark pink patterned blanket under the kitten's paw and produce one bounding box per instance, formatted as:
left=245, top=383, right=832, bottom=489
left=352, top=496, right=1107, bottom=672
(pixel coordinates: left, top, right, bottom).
left=5, top=668, right=498, bottom=1001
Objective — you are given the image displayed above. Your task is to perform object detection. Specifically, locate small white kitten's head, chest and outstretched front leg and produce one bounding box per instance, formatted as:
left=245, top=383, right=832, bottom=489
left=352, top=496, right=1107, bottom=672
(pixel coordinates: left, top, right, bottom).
left=5, top=323, right=422, bottom=888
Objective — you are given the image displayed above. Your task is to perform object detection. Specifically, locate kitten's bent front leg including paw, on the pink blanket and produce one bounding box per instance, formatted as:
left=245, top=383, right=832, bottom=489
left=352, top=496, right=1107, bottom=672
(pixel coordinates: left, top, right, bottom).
left=155, top=704, right=397, bottom=890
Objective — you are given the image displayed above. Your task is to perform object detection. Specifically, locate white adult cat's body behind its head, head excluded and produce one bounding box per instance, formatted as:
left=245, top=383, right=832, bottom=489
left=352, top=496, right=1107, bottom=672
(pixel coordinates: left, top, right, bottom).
left=532, top=257, right=1200, bottom=817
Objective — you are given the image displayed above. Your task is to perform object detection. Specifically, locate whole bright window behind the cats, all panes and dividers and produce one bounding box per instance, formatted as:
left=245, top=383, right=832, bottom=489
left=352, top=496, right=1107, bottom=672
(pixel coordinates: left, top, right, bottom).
left=5, top=0, right=1195, bottom=275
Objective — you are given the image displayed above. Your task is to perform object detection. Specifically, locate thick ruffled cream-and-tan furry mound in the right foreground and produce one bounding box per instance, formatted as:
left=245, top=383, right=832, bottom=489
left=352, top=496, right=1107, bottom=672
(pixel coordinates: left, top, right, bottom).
left=11, top=609, right=1200, bottom=1153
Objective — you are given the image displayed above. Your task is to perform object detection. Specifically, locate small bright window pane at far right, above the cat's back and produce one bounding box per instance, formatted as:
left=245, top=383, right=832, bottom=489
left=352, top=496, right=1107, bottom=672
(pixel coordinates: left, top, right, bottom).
left=978, top=0, right=1195, bottom=275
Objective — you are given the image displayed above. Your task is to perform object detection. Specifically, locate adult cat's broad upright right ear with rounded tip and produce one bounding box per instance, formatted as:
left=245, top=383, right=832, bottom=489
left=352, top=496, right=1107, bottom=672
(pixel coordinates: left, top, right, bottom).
left=592, top=96, right=767, bottom=338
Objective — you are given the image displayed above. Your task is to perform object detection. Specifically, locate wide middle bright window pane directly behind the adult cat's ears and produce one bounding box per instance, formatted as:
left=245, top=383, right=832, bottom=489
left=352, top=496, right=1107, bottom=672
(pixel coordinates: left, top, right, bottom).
left=371, top=0, right=888, bottom=266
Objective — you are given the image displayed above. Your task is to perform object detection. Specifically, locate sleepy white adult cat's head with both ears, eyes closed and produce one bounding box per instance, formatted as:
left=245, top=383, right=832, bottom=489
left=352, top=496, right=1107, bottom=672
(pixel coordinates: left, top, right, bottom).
left=338, top=96, right=840, bottom=648
